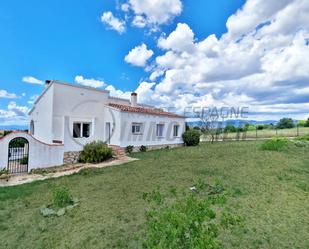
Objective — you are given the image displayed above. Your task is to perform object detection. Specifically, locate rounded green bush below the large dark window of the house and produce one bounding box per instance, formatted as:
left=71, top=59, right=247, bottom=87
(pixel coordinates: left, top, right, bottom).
left=79, top=141, right=113, bottom=163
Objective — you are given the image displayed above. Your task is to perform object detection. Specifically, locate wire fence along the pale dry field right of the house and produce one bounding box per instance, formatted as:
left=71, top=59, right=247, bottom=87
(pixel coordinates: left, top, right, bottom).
left=201, top=126, right=309, bottom=141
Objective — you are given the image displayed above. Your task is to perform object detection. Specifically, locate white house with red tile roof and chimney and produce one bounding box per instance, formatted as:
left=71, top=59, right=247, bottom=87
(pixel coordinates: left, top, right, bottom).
left=29, top=80, right=185, bottom=152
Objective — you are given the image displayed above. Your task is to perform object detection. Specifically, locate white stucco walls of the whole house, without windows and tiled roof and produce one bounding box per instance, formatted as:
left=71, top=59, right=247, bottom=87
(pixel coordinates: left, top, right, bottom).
left=27, top=82, right=185, bottom=152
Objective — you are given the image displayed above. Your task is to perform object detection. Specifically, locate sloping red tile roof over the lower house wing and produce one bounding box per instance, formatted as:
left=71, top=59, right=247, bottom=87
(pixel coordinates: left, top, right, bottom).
left=108, top=103, right=185, bottom=118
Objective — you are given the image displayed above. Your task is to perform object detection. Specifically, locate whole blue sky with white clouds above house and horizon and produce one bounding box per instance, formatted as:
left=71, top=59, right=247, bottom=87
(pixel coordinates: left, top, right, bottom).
left=0, top=0, right=309, bottom=124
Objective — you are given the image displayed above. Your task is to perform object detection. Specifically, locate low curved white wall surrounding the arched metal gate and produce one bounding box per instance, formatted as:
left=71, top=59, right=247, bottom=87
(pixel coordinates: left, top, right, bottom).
left=0, top=132, right=64, bottom=172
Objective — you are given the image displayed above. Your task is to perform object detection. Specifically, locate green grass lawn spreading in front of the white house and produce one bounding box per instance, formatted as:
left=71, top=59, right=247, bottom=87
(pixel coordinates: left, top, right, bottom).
left=0, top=141, right=309, bottom=249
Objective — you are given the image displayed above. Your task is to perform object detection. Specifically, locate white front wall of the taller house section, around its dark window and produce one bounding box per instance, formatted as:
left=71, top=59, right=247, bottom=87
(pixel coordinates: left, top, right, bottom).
left=53, top=83, right=120, bottom=152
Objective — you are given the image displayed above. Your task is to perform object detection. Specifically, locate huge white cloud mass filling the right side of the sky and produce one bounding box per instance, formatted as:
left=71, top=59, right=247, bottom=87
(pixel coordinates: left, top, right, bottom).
left=131, top=0, right=309, bottom=119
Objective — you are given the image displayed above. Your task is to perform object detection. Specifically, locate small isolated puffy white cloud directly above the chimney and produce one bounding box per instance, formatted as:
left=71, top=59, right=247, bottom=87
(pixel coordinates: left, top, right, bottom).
left=124, top=43, right=153, bottom=67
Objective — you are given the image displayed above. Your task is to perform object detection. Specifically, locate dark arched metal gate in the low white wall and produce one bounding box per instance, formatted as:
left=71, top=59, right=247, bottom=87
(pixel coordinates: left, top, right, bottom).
left=8, top=137, right=29, bottom=174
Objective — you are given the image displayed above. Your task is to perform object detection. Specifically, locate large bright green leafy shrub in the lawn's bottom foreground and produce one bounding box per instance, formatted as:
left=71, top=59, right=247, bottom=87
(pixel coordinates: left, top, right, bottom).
left=142, top=191, right=221, bottom=249
